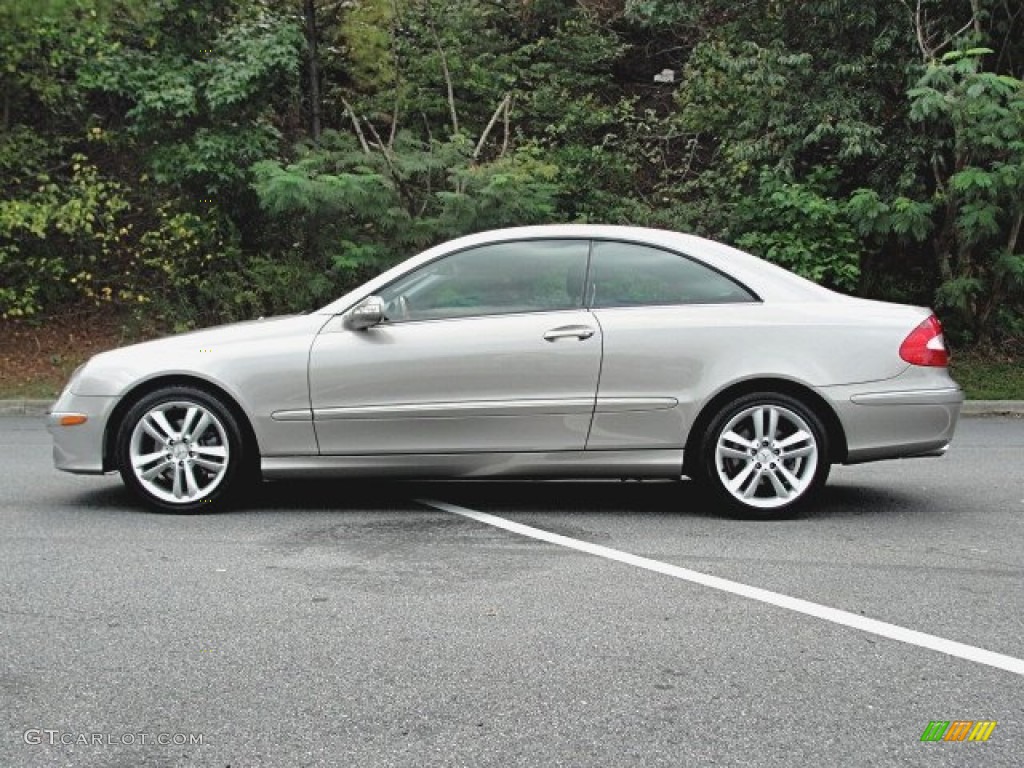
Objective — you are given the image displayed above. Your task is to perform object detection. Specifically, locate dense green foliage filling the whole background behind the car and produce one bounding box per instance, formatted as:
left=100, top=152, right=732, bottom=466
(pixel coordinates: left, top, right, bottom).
left=0, top=0, right=1024, bottom=341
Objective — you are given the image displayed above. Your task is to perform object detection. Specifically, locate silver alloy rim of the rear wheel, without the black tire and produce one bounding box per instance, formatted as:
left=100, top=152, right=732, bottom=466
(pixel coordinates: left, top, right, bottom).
left=715, top=406, right=818, bottom=509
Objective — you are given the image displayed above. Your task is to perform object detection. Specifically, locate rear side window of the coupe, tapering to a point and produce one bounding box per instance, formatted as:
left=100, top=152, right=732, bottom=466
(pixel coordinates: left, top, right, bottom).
left=590, top=242, right=757, bottom=307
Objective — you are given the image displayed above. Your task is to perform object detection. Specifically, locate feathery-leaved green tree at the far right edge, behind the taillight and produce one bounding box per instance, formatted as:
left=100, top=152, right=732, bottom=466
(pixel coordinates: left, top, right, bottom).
left=909, top=48, right=1024, bottom=340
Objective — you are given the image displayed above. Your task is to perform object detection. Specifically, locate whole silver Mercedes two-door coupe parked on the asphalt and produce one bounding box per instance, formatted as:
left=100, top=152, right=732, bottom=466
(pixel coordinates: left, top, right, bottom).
left=48, top=225, right=964, bottom=518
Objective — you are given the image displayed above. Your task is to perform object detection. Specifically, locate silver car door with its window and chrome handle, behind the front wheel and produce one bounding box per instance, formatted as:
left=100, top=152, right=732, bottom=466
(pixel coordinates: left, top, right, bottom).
left=309, top=240, right=601, bottom=455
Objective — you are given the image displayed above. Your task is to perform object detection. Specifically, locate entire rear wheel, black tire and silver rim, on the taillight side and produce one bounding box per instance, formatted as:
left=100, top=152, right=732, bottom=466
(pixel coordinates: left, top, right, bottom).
left=693, top=392, right=831, bottom=520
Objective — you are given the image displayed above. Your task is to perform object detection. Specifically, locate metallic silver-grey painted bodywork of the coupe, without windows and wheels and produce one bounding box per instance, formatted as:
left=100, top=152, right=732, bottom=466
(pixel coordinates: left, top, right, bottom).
left=49, top=225, right=963, bottom=495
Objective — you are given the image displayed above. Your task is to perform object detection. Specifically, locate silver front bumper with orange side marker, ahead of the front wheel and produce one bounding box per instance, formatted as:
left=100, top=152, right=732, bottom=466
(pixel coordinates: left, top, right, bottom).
left=46, top=390, right=120, bottom=475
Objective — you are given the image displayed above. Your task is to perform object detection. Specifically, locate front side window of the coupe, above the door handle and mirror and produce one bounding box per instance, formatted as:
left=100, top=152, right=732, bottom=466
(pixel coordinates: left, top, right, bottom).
left=380, top=240, right=590, bottom=323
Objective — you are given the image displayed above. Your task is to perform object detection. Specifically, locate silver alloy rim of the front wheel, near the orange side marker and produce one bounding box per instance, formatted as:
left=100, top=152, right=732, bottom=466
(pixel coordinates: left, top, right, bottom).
left=128, top=400, right=230, bottom=504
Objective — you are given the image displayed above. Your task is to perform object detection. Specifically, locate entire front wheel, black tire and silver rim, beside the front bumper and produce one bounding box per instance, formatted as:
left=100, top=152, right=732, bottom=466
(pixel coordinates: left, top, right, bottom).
left=115, top=386, right=254, bottom=514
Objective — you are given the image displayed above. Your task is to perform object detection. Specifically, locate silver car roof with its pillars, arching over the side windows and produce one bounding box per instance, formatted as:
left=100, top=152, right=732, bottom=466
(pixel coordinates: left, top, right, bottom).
left=319, top=224, right=839, bottom=314
